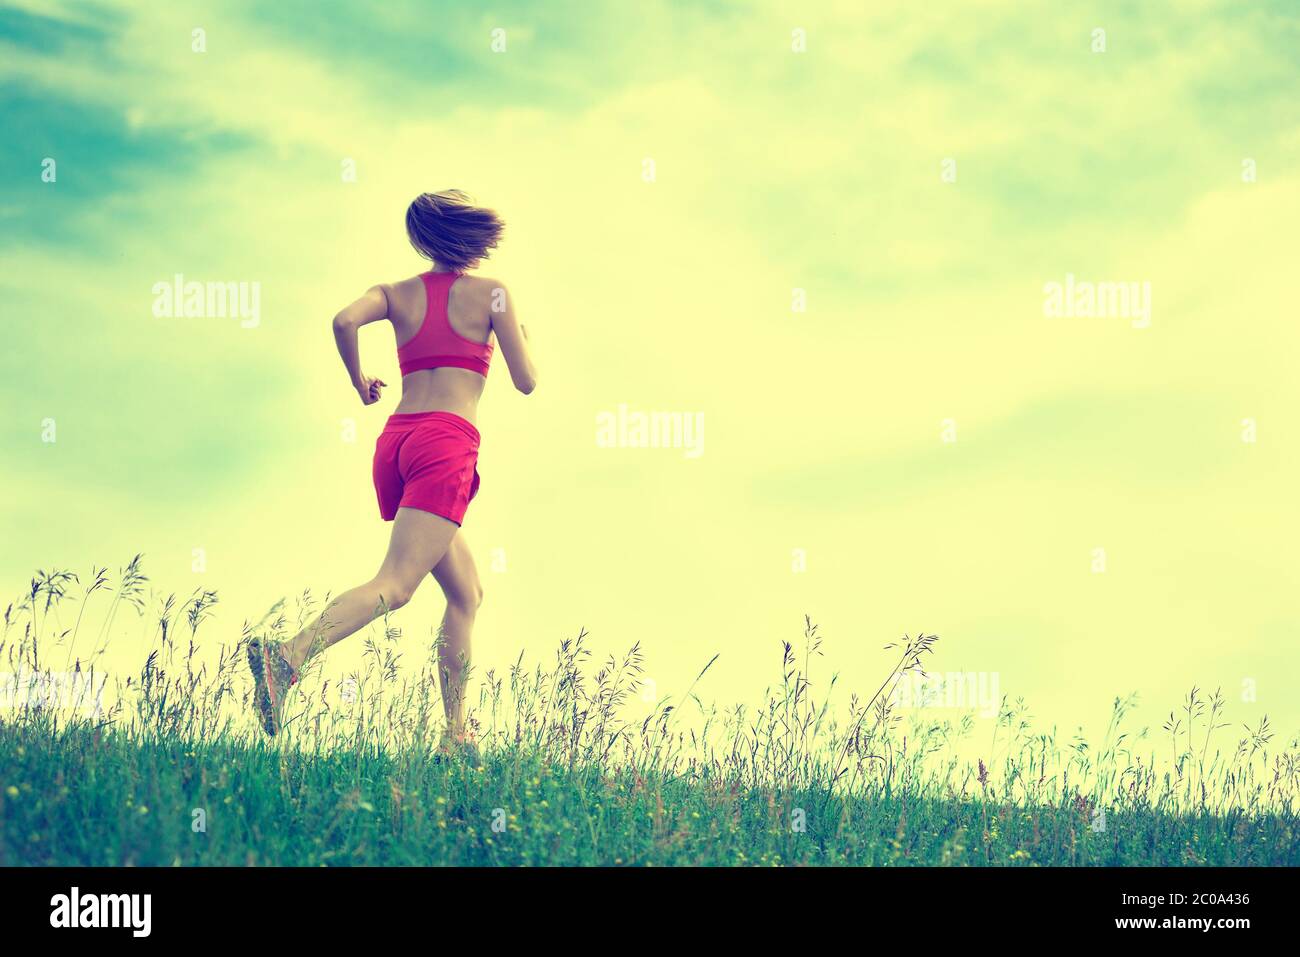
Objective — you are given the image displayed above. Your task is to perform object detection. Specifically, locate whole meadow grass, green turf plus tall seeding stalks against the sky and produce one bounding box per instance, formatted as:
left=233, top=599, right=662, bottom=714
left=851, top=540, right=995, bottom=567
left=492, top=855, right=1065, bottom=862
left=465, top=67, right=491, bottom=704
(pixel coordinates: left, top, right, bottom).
left=0, top=557, right=1300, bottom=866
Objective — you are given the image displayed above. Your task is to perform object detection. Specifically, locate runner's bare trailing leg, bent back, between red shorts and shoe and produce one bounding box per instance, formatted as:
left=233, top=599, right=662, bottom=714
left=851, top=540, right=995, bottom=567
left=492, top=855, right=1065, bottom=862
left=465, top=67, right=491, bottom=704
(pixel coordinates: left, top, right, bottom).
left=282, top=508, right=456, bottom=668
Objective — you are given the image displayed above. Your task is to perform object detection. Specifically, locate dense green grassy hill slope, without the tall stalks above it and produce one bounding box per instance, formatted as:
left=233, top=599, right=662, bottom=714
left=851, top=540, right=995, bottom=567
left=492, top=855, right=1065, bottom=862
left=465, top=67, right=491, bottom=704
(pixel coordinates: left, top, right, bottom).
left=0, top=726, right=1300, bottom=866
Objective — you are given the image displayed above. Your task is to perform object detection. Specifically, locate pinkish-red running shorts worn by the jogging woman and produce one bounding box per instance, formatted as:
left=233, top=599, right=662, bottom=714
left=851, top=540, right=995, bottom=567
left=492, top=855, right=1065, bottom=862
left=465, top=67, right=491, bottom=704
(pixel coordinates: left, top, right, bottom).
left=373, top=412, right=478, bottom=525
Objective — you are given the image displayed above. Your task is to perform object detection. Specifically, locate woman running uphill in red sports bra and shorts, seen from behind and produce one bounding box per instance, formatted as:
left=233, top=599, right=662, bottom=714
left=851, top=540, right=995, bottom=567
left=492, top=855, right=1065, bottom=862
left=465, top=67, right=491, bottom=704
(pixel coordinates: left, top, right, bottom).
left=248, top=190, right=537, bottom=749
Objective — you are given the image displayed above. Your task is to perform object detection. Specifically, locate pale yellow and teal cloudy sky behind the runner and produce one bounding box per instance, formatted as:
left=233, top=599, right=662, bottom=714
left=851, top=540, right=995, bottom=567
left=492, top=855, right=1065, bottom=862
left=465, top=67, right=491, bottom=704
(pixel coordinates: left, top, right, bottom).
left=0, top=0, right=1300, bottom=736
